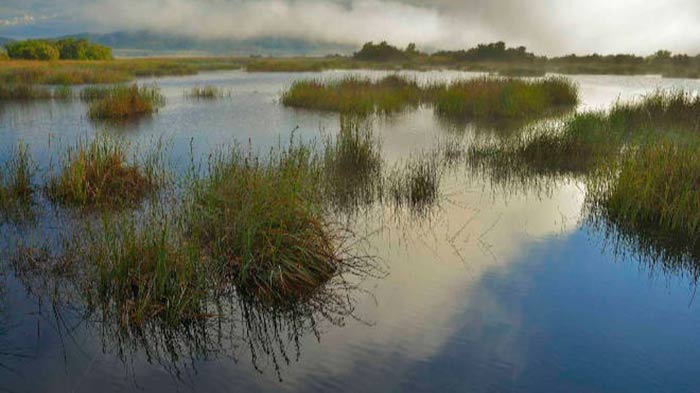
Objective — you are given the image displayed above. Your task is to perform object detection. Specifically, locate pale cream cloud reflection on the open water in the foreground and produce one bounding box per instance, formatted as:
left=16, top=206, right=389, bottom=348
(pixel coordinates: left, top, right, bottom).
left=270, top=173, right=583, bottom=391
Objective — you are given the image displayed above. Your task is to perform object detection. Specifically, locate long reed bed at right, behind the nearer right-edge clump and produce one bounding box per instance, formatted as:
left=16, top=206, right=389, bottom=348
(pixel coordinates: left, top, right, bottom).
left=469, top=92, right=700, bottom=175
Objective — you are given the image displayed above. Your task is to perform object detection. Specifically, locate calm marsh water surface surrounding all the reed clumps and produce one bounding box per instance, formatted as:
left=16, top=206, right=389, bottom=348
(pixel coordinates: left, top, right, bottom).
left=0, top=71, right=700, bottom=392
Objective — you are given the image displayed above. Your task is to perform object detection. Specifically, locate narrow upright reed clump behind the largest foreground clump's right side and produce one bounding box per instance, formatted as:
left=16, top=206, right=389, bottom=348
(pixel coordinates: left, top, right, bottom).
left=323, top=116, right=384, bottom=208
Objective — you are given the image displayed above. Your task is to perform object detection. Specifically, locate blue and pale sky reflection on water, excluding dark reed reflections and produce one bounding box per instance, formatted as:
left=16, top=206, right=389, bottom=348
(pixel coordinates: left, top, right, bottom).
left=0, top=72, right=700, bottom=391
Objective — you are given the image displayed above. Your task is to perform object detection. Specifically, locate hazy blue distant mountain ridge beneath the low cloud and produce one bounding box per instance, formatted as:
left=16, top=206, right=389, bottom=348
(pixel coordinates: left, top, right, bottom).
left=61, top=31, right=355, bottom=56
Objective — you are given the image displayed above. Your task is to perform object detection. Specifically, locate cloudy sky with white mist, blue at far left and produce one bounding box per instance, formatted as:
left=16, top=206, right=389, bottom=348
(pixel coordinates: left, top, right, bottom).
left=0, top=0, right=700, bottom=55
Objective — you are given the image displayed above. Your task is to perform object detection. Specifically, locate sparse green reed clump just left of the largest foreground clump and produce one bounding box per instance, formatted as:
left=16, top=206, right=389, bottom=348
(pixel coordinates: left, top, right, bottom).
left=77, top=209, right=208, bottom=327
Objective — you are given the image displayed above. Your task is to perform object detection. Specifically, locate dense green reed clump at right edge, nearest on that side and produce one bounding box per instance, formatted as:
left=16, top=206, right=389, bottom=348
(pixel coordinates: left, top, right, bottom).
left=589, top=141, right=700, bottom=244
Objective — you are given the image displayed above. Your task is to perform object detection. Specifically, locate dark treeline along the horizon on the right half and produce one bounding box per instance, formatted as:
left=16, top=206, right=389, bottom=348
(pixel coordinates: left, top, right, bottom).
left=353, top=42, right=700, bottom=77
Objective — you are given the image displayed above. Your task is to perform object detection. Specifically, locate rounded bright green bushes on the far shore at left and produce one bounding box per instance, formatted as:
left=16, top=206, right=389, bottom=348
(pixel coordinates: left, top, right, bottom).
left=5, top=38, right=112, bottom=60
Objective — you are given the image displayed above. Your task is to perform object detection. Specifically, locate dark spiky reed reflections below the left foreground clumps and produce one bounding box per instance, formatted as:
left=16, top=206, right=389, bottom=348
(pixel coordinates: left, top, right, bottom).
left=6, top=233, right=386, bottom=383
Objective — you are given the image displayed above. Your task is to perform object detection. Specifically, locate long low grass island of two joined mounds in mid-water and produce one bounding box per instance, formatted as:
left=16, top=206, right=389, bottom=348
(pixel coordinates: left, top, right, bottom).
left=281, top=75, right=578, bottom=120
